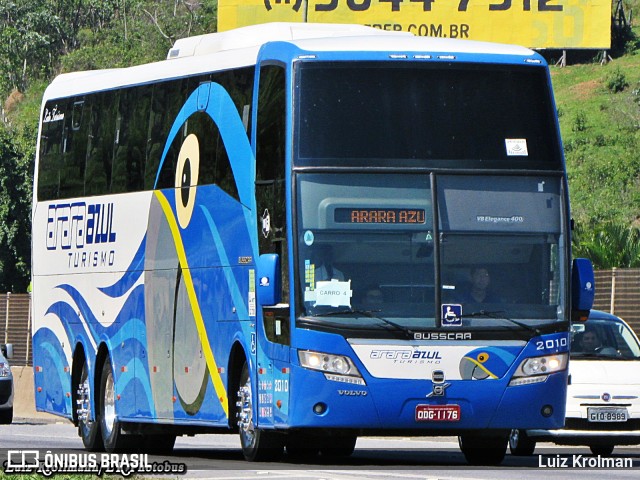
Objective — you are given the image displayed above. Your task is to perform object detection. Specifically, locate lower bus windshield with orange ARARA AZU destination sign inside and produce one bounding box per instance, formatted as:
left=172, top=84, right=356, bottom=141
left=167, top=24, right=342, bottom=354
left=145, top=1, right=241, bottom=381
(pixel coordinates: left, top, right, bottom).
left=297, top=173, right=566, bottom=329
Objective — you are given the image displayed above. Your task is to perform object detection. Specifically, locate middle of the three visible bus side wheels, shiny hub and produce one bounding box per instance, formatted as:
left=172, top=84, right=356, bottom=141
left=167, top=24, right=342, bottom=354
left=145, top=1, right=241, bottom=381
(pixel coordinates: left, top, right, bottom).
left=98, top=356, right=140, bottom=453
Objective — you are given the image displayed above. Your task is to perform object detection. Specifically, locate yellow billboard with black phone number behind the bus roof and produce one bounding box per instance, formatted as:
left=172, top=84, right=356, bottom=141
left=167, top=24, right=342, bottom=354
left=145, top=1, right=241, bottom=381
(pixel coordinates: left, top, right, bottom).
left=218, top=0, right=611, bottom=49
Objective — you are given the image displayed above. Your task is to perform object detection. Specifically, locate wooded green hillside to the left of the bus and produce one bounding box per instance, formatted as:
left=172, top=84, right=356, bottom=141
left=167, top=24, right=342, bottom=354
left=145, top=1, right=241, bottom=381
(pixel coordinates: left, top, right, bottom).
left=0, top=0, right=217, bottom=292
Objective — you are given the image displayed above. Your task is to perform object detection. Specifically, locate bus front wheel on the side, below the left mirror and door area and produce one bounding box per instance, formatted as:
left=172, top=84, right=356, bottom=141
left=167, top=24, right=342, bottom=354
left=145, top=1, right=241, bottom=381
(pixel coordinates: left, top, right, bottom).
left=236, top=361, right=284, bottom=462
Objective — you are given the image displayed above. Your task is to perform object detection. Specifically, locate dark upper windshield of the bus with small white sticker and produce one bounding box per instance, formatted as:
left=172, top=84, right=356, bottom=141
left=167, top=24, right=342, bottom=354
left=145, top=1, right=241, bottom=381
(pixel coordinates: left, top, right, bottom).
left=294, top=62, right=563, bottom=171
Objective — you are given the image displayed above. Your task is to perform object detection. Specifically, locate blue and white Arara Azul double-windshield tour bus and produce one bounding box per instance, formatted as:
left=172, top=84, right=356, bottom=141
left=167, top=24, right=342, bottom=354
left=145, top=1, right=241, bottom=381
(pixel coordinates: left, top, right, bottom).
left=32, top=24, right=593, bottom=463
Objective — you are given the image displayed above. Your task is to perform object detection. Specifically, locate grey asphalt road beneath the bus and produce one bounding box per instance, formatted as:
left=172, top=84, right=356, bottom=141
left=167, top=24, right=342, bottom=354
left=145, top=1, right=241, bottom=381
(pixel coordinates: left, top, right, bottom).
left=0, top=419, right=640, bottom=480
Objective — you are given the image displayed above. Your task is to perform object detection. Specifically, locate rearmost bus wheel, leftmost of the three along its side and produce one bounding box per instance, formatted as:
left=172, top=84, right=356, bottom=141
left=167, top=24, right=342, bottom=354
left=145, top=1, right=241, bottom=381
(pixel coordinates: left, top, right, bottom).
left=72, top=358, right=104, bottom=452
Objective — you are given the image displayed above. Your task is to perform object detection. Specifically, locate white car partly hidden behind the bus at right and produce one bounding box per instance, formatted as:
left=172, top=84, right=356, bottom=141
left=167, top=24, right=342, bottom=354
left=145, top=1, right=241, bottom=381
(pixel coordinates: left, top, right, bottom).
left=509, top=310, right=640, bottom=456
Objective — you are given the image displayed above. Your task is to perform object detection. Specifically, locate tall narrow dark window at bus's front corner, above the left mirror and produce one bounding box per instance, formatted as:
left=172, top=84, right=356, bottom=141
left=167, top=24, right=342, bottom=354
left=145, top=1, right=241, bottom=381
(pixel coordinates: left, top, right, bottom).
left=256, top=65, right=289, bottom=303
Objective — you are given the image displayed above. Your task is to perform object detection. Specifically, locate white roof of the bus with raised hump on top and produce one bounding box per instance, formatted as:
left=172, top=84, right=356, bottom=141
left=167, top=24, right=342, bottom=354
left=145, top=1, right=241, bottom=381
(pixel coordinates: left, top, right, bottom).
left=44, top=23, right=535, bottom=101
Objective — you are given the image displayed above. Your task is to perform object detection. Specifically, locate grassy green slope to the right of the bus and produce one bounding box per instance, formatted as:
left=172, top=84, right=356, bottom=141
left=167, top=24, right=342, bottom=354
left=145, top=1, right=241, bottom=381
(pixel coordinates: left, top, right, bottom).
left=551, top=0, right=640, bottom=268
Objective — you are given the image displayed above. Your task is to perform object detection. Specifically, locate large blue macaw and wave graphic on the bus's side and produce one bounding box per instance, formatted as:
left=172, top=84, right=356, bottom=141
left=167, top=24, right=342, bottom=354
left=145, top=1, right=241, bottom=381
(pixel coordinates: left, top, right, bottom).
left=34, top=83, right=258, bottom=421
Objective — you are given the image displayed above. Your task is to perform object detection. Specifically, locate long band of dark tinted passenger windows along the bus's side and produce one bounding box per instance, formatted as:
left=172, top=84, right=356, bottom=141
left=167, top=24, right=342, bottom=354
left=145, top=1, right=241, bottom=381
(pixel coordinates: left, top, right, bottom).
left=38, top=68, right=254, bottom=200
